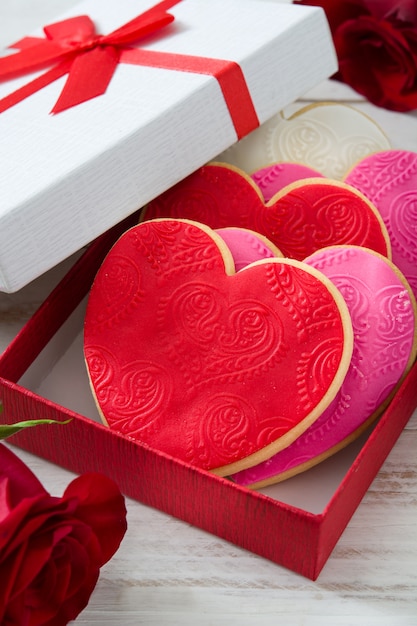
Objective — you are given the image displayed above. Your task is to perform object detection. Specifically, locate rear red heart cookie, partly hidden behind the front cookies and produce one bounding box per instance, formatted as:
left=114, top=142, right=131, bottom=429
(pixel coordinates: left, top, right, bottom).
left=144, top=164, right=391, bottom=260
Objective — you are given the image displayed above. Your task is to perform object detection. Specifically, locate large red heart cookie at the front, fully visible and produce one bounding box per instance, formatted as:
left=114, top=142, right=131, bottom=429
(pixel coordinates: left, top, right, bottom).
left=84, top=220, right=353, bottom=475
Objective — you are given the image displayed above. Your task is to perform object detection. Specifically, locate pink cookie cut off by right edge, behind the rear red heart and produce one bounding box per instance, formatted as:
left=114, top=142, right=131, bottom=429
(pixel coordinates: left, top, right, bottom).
left=345, top=150, right=417, bottom=297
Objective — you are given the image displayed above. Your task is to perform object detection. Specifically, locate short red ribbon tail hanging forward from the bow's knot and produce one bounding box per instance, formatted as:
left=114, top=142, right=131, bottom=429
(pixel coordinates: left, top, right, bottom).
left=51, top=46, right=119, bottom=113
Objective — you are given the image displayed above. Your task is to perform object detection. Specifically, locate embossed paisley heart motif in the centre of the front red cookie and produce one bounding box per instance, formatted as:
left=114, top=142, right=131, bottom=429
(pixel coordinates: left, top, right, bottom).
left=158, top=282, right=288, bottom=393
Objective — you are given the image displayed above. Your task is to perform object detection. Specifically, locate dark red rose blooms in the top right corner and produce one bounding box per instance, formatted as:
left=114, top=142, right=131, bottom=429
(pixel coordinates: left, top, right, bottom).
left=297, top=0, right=417, bottom=111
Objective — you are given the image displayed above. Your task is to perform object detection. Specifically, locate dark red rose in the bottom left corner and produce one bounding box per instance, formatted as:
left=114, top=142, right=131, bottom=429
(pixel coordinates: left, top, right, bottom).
left=0, top=445, right=126, bottom=626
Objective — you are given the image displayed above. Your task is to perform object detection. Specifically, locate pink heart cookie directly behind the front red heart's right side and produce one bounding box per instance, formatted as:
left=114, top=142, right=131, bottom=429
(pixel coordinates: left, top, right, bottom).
left=233, top=246, right=417, bottom=488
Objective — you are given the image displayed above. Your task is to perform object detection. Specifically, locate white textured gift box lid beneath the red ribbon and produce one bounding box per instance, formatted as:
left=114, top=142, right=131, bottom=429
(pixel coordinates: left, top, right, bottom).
left=0, top=0, right=337, bottom=292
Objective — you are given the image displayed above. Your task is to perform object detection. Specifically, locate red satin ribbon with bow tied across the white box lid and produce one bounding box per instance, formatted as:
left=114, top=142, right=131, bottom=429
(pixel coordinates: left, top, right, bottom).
left=0, top=0, right=259, bottom=139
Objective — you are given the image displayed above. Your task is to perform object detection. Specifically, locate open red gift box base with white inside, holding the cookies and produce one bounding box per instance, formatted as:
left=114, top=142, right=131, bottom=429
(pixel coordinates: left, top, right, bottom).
left=0, top=217, right=417, bottom=580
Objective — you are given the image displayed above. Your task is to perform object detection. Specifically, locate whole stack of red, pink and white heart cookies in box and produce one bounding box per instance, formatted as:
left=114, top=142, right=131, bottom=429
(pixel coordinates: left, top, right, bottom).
left=84, top=105, right=417, bottom=488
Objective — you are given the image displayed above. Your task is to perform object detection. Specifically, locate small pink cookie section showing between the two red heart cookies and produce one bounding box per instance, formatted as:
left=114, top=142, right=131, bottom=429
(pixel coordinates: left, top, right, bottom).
left=215, top=227, right=277, bottom=272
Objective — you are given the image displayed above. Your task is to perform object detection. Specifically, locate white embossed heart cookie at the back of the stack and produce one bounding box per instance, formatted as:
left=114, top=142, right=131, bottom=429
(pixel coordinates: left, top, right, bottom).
left=216, top=102, right=391, bottom=180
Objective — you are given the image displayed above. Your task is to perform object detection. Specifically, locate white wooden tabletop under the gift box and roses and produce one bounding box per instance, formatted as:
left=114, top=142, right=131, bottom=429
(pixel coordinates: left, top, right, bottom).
left=0, top=0, right=417, bottom=626
